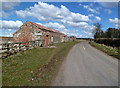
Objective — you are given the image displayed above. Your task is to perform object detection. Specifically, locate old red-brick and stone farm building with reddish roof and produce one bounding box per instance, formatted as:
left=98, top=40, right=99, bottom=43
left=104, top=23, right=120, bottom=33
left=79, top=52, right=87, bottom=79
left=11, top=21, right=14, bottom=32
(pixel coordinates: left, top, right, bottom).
left=13, top=21, right=69, bottom=46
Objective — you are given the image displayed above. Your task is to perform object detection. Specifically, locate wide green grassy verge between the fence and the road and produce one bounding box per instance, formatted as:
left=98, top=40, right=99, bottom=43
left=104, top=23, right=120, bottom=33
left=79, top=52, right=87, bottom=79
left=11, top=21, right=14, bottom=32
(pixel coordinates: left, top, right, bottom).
left=2, top=41, right=78, bottom=86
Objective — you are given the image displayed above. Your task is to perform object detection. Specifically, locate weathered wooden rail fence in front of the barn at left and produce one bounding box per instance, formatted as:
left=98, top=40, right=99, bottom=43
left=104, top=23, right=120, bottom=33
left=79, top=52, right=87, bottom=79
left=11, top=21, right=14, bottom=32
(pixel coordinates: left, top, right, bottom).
left=0, top=40, right=44, bottom=59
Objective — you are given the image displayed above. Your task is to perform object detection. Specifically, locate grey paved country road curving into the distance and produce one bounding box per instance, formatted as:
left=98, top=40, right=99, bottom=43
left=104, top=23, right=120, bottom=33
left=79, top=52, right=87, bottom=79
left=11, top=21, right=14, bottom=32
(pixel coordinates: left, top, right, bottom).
left=52, top=42, right=118, bottom=86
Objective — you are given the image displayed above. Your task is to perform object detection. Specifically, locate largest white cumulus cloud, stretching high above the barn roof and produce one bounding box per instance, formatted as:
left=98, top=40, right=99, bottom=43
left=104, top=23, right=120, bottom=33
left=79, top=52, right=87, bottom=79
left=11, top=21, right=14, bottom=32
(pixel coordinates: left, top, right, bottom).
left=16, top=2, right=89, bottom=27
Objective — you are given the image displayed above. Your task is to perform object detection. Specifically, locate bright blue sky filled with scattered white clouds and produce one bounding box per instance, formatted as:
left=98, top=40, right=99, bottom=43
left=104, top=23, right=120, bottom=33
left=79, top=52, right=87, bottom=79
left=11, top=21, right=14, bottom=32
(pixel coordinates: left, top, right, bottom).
left=0, top=1, right=118, bottom=38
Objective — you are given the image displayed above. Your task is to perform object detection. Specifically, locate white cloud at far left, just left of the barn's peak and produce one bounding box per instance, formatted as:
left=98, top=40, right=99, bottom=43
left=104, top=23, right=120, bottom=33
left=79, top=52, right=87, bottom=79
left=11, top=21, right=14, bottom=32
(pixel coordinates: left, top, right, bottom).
left=0, top=20, right=23, bottom=29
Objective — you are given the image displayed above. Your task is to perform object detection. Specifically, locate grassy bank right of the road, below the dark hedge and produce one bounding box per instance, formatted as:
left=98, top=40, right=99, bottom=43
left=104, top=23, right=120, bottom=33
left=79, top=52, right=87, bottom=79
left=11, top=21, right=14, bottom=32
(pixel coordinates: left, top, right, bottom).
left=90, top=41, right=120, bottom=59
